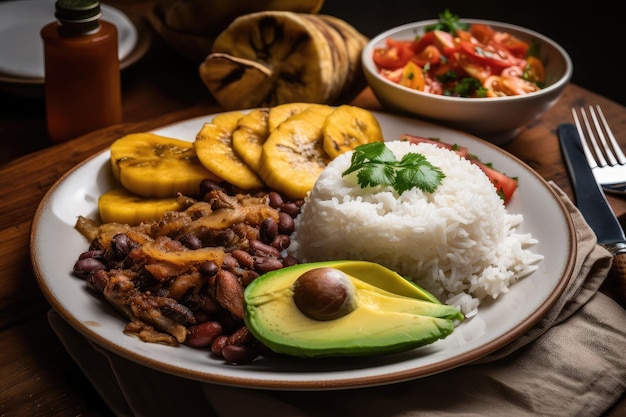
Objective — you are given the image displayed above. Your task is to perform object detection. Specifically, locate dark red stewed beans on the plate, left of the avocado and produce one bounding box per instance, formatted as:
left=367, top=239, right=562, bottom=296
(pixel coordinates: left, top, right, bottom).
left=74, top=180, right=302, bottom=363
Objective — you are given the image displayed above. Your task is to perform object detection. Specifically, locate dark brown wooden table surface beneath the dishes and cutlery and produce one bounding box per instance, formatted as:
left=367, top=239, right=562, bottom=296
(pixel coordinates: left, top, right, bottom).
left=0, top=3, right=626, bottom=417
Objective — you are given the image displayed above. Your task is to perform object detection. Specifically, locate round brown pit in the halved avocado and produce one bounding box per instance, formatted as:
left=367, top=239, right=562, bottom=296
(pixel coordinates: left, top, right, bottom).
left=293, top=267, right=357, bottom=321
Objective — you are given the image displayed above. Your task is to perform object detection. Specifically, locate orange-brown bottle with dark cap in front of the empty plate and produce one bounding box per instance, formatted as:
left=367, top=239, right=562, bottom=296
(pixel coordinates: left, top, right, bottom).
left=41, top=0, right=122, bottom=143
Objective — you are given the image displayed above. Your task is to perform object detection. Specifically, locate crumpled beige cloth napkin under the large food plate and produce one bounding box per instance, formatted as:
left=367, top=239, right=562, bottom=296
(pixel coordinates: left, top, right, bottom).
left=49, top=184, right=626, bottom=417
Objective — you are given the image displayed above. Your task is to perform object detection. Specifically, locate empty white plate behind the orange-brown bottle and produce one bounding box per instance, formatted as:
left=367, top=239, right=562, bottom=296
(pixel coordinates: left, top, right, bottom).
left=0, top=0, right=138, bottom=82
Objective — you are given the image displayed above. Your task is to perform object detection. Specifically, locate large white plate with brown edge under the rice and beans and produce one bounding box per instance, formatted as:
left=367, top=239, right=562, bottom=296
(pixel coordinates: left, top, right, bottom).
left=31, top=113, right=576, bottom=390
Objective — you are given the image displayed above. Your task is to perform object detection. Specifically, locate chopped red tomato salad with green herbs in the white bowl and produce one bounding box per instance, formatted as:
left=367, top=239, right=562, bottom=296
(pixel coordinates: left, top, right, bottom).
left=373, top=10, right=545, bottom=98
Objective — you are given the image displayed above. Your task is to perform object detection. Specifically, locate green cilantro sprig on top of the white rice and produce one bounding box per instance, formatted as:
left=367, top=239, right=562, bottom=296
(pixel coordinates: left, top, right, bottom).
left=342, top=142, right=445, bottom=194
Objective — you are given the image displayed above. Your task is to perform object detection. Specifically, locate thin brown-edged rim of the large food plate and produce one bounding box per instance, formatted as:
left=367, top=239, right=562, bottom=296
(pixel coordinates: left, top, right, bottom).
left=29, top=111, right=577, bottom=391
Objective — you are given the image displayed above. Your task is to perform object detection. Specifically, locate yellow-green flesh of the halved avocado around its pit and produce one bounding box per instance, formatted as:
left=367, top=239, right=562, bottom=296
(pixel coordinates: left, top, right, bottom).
left=244, top=261, right=464, bottom=357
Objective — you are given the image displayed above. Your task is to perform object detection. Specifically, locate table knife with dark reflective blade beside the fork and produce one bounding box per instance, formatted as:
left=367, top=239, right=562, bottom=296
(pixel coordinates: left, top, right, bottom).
left=557, top=123, right=626, bottom=297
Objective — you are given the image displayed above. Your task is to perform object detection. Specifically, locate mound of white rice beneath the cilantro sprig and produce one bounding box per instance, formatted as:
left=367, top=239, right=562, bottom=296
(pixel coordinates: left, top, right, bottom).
left=288, top=141, right=543, bottom=316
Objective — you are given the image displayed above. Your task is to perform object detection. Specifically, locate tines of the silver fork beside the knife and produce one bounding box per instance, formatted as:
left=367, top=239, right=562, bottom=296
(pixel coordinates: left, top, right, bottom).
left=572, top=105, right=626, bottom=167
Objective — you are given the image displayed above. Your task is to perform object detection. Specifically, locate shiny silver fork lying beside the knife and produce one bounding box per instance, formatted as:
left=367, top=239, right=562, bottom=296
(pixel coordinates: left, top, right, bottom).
left=572, top=105, right=626, bottom=195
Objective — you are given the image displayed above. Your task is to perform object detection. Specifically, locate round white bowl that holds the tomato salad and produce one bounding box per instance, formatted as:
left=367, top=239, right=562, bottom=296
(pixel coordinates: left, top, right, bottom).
left=361, top=19, right=573, bottom=145
